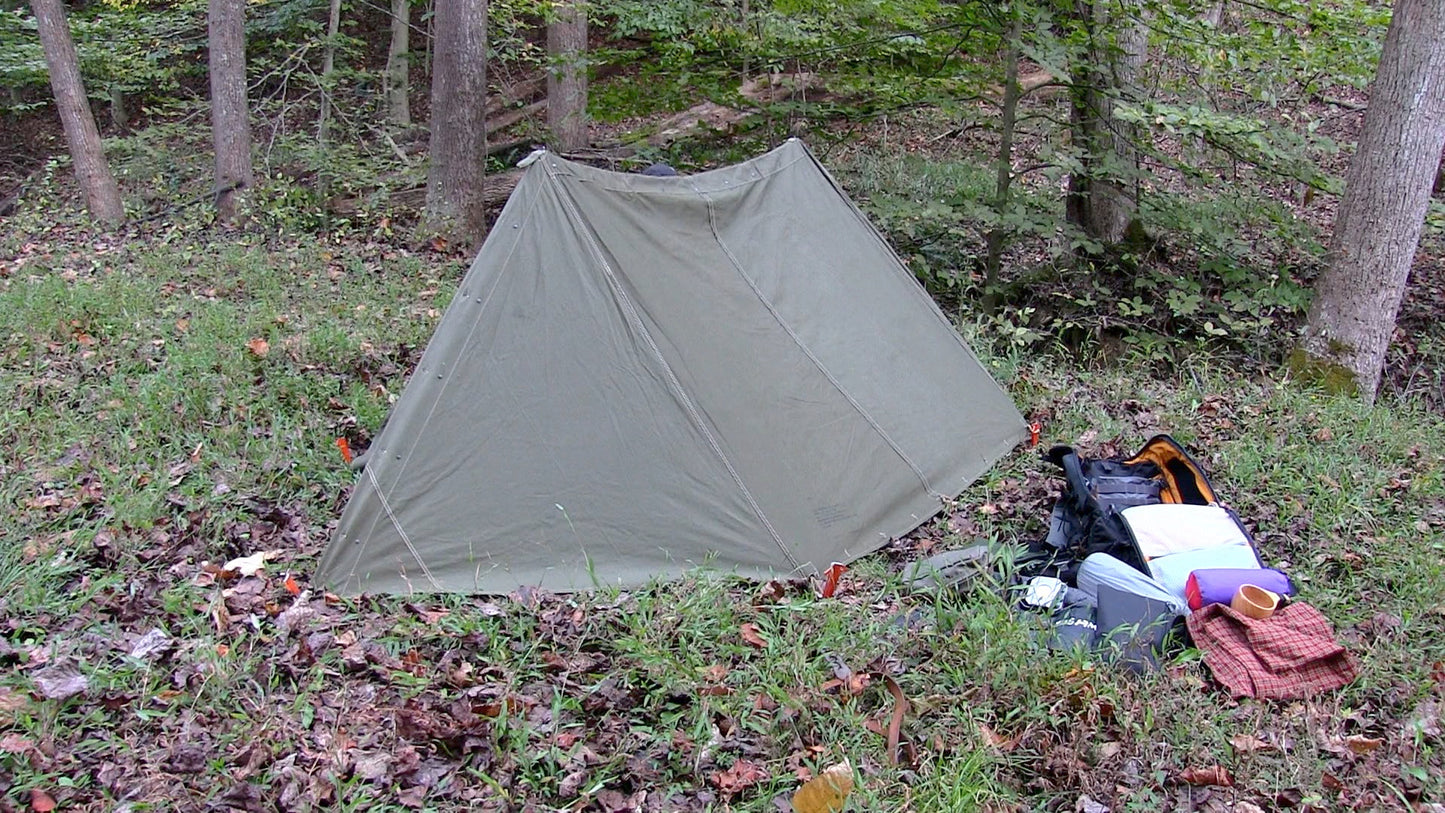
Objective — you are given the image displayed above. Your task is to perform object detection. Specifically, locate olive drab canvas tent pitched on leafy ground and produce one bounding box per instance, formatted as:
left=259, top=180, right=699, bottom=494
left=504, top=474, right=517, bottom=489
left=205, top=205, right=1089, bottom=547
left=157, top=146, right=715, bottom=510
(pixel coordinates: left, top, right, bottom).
left=319, top=140, right=1025, bottom=594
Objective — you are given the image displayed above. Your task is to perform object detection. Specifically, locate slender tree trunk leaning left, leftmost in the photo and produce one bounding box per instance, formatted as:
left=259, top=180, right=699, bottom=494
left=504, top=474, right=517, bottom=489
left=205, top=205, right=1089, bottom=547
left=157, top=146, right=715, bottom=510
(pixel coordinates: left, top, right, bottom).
left=30, top=0, right=126, bottom=227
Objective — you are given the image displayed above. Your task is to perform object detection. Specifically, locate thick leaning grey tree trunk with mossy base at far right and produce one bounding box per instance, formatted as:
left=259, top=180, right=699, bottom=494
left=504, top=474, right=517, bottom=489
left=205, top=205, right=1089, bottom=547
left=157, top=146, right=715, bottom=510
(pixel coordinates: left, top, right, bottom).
left=1296, top=0, right=1445, bottom=400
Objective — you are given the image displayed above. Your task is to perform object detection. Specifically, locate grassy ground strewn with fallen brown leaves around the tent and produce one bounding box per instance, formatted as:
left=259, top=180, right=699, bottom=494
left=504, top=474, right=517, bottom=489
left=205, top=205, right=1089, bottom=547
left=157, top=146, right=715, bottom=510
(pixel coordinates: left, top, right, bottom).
left=0, top=104, right=1445, bottom=812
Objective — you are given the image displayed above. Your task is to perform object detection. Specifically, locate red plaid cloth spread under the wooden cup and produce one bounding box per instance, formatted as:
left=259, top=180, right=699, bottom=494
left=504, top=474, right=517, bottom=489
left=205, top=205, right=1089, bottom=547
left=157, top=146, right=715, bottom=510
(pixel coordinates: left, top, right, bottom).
left=1188, top=602, right=1360, bottom=700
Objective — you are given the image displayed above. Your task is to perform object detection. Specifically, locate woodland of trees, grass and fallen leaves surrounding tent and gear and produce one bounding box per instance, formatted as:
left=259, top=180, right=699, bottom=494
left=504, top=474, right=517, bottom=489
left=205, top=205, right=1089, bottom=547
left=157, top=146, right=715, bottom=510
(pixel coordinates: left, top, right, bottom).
left=0, top=0, right=1445, bottom=813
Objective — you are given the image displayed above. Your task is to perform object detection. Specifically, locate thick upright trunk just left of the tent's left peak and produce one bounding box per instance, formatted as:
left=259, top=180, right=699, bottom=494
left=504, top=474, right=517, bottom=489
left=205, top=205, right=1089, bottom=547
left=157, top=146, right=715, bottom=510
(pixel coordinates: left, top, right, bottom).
left=425, top=0, right=487, bottom=245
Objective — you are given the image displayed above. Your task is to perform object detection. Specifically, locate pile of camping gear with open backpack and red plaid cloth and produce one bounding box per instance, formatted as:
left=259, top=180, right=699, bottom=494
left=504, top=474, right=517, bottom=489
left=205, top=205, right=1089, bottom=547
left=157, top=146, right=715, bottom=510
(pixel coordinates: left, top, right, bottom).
left=1020, top=435, right=1358, bottom=699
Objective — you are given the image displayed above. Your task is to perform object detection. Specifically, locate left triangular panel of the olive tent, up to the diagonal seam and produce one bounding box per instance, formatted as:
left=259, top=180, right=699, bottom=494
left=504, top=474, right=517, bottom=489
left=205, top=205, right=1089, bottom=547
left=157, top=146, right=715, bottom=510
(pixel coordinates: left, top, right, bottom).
left=322, top=171, right=790, bottom=592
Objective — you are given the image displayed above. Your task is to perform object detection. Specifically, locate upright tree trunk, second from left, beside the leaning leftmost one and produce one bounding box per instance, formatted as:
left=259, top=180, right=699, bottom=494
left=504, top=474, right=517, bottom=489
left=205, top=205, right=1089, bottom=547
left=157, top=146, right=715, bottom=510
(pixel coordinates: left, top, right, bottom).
left=208, top=0, right=256, bottom=221
